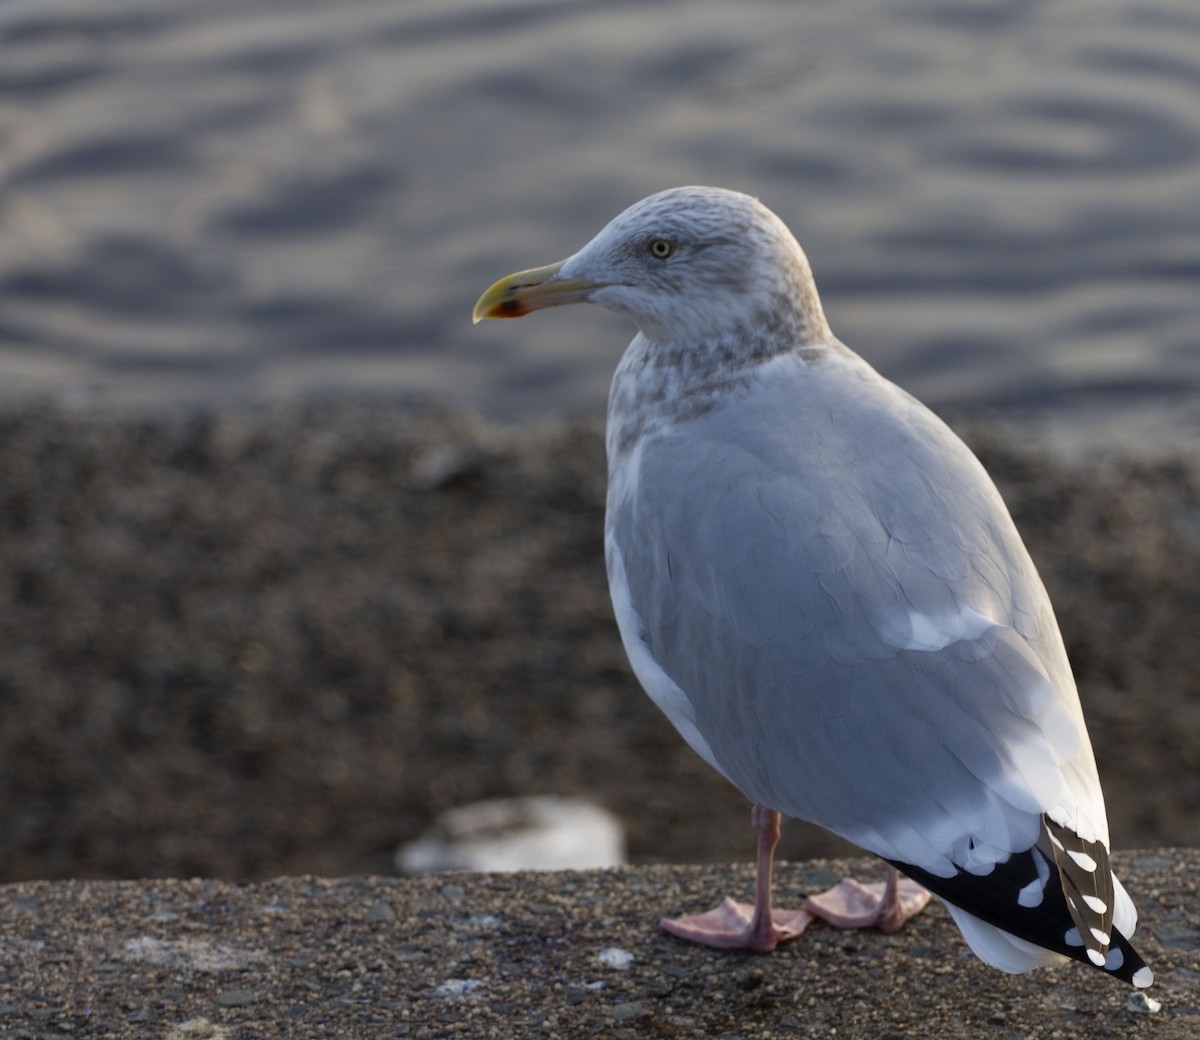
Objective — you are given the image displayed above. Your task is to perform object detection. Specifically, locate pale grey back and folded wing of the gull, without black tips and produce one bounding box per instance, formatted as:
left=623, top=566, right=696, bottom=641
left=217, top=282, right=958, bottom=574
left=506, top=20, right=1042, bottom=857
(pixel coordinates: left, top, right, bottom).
left=607, top=359, right=1106, bottom=876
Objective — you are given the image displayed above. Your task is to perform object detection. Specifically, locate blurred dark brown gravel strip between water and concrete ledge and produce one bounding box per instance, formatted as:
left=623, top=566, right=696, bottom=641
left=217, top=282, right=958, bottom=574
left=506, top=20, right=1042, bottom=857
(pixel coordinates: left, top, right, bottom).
left=0, top=403, right=1200, bottom=880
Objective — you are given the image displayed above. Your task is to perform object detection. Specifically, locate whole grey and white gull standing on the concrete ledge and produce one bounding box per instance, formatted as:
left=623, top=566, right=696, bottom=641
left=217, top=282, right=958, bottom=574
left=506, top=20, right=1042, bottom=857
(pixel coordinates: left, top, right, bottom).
left=474, top=187, right=1153, bottom=987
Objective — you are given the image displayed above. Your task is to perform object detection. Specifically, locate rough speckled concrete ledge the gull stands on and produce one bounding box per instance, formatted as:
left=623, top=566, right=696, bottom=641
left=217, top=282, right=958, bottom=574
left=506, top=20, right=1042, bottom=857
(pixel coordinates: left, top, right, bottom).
left=0, top=849, right=1200, bottom=1040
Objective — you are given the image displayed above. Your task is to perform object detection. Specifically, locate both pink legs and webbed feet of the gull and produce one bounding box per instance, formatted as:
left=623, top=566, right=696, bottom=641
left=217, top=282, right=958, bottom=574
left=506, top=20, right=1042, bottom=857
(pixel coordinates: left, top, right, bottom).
left=661, top=805, right=930, bottom=954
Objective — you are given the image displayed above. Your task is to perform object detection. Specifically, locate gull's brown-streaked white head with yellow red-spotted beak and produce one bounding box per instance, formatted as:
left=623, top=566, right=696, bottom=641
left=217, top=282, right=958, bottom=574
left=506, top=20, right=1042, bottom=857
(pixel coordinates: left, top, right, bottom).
left=474, top=187, right=829, bottom=345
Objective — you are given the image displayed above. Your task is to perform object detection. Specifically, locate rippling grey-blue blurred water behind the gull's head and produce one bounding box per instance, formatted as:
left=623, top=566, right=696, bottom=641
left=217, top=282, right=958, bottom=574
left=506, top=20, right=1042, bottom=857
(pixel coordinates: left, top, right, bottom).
left=0, top=0, right=1200, bottom=453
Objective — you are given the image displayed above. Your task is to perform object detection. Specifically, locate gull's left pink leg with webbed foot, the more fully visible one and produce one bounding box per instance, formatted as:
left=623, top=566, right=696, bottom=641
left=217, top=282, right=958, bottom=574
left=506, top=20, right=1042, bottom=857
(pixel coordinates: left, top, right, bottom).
left=661, top=805, right=815, bottom=954
